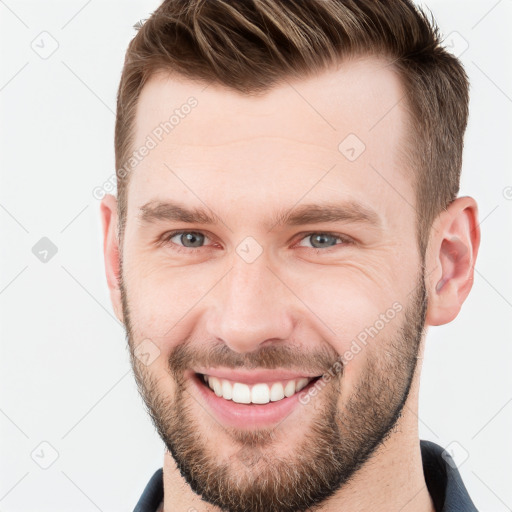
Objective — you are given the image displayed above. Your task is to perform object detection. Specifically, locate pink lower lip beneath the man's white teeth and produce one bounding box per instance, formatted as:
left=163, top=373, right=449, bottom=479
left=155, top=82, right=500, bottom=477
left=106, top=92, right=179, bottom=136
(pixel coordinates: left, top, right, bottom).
left=191, top=374, right=316, bottom=429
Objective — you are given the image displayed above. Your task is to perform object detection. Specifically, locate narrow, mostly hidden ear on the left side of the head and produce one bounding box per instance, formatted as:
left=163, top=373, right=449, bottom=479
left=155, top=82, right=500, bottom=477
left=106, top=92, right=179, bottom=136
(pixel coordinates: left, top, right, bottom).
left=100, top=194, right=123, bottom=322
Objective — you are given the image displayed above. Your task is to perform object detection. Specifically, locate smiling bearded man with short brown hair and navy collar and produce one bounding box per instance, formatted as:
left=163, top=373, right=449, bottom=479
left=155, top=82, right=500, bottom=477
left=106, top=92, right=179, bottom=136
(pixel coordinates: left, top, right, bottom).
left=101, top=0, right=480, bottom=512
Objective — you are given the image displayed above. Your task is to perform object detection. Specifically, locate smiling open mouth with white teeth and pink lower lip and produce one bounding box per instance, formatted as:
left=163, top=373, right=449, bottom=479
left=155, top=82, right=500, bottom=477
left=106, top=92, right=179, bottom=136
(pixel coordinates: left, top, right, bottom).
left=191, top=372, right=322, bottom=429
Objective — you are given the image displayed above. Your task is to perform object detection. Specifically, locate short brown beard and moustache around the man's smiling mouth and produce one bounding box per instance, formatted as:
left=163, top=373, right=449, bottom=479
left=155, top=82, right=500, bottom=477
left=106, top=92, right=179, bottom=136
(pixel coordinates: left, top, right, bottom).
left=120, top=272, right=427, bottom=512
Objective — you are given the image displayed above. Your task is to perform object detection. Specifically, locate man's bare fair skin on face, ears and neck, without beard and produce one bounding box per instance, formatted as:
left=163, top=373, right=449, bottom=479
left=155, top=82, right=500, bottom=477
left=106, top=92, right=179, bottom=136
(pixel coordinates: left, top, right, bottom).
left=101, top=57, right=480, bottom=512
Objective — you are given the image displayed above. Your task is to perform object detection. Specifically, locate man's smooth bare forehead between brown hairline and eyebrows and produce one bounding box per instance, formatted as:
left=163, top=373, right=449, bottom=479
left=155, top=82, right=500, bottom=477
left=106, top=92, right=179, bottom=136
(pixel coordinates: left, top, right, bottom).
left=128, top=54, right=414, bottom=226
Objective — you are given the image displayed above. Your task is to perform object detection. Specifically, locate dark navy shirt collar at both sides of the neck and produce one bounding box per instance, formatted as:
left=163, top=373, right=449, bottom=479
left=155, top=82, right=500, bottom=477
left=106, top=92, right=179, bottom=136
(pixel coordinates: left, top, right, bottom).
left=134, top=440, right=478, bottom=512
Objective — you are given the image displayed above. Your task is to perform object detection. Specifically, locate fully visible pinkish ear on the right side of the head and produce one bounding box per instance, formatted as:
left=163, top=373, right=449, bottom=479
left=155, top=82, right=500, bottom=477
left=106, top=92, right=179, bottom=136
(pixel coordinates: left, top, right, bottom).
left=425, top=197, right=480, bottom=325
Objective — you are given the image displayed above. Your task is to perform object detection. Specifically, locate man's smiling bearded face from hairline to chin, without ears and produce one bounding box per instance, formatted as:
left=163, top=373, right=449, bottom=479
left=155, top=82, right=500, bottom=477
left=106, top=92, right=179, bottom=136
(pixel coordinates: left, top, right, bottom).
left=117, top=59, right=426, bottom=512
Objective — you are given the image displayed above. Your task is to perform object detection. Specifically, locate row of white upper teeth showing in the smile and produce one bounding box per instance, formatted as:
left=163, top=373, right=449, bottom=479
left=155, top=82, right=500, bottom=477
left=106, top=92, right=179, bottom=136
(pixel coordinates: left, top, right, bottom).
left=203, top=375, right=313, bottom=404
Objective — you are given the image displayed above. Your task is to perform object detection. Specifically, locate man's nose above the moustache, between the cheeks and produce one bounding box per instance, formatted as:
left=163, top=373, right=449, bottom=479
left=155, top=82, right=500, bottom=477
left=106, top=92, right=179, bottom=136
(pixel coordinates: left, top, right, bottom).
left=207, top=257, right=294, bottom=353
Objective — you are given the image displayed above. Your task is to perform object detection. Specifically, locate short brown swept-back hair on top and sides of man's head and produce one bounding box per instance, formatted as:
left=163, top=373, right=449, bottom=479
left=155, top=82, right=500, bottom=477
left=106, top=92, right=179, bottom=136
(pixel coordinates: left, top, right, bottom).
left=115, top=0, right=469, bottom=255
